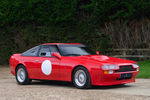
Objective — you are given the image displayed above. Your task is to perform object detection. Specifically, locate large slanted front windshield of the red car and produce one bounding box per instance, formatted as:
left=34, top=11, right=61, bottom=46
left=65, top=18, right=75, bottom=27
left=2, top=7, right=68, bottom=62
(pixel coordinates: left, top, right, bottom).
left=59, top=45, right=95, bottom=56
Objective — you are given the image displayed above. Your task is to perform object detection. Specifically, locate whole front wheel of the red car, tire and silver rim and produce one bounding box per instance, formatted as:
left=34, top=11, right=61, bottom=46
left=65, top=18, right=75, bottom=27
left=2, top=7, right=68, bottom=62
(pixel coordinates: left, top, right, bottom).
left=72, top=67, right=91, bottom=89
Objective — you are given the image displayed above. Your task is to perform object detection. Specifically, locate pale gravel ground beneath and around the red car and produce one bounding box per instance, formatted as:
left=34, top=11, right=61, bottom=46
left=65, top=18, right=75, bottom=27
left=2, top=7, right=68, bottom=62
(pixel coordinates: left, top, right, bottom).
left=0, top=67, right=150, bottom=100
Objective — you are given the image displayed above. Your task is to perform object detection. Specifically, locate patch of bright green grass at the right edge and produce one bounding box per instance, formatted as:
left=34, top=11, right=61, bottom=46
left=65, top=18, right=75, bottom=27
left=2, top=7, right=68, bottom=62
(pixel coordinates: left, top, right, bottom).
left=137, top=60, right=150, bottom=78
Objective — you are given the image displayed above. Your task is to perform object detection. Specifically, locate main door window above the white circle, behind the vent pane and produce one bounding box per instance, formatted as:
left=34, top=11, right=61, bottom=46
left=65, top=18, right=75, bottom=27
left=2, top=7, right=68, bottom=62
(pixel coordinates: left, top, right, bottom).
left=39, top=46, right=51, bottom=57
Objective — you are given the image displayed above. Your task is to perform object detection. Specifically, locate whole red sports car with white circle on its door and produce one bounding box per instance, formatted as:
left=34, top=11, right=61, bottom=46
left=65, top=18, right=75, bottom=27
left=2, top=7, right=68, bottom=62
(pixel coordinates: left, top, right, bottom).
left=10, top=43, right=139, bottom=88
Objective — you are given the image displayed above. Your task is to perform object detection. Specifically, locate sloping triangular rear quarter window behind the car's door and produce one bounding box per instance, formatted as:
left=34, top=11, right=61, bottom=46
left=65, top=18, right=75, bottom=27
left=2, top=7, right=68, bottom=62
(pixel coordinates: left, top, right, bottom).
left=22, top=46, right=40, bottom=56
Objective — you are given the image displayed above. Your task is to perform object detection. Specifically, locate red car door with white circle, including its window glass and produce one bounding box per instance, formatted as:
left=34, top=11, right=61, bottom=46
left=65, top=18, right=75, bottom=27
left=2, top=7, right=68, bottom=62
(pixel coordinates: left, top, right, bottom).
left=35, top=45, right=60, bottom=80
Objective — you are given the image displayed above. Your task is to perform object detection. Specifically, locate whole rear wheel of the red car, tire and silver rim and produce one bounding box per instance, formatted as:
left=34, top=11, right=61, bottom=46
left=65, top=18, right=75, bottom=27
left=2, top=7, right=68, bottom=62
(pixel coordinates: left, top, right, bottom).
left=16, top=65, right=32, bottom=85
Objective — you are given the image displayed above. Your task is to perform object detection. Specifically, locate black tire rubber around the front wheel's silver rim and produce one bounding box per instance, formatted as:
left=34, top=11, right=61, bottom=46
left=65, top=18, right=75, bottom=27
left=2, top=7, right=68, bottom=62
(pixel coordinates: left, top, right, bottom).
left=72, top=67, right=91, bottom=89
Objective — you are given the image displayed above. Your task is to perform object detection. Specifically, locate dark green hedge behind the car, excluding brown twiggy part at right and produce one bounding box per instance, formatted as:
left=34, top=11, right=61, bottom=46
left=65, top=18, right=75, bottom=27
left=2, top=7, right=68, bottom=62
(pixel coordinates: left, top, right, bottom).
left=0, top=0, right=150, bottom=64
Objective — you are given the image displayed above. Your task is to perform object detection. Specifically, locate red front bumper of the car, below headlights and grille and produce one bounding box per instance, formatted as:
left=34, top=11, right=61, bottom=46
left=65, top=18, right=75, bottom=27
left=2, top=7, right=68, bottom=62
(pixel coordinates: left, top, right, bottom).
left=93, top=71, right=138, bottom=86
